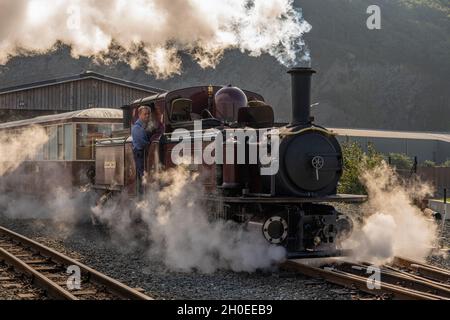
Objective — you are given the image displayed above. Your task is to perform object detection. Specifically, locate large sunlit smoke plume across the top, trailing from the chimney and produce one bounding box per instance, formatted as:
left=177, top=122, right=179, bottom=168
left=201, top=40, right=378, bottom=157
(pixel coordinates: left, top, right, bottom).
left=0, top=0, right=311, bottom=77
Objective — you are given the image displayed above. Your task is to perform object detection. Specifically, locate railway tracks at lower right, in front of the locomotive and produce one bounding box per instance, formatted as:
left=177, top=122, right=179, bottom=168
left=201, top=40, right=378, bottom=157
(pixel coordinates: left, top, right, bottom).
left=282, top=257, right=450, bottom=300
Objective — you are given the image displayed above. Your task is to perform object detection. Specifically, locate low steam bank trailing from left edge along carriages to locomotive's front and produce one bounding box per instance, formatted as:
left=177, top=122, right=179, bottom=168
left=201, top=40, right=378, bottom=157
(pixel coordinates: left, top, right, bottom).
left=0, top=127, right=285, bottom=273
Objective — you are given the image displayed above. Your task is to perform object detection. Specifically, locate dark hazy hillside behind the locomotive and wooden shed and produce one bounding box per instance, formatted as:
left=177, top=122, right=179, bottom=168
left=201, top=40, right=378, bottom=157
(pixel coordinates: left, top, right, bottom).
left=0, top=0, right=450, bottom=131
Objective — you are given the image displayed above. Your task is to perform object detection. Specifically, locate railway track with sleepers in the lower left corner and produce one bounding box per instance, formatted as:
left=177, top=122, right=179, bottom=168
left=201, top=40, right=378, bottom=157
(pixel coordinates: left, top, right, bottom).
left=0, top=227, right=152, bottom=300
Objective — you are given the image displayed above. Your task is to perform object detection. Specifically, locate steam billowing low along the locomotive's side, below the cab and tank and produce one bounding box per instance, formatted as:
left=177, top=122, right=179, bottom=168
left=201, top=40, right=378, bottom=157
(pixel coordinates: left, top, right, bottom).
left=94, top=168, right=285, bottom=273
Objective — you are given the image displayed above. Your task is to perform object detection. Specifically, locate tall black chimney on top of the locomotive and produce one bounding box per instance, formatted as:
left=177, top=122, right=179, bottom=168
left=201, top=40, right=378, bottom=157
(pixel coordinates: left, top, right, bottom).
left=288, top=68, right=316, bottom=125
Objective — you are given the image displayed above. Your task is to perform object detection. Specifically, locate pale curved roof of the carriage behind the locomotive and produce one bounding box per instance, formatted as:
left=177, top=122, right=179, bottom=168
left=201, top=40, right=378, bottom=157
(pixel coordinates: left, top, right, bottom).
left=0, top=108, right=123, bottom=130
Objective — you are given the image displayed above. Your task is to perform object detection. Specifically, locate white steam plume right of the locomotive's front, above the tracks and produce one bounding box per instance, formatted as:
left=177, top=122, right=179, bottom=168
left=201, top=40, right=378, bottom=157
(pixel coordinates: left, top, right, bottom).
left=344, top=163, right=437, bottom=263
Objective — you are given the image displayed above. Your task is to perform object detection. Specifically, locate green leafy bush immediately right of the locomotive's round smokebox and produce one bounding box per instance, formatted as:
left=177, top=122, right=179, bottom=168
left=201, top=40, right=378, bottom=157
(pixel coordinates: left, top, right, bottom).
left=338, top=142, right=384, bottom=194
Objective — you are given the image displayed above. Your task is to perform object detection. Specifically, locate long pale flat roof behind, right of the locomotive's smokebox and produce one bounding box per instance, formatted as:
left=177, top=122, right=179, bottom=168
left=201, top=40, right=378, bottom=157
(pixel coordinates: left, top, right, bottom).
left=329, top=128, right=450, bottom=143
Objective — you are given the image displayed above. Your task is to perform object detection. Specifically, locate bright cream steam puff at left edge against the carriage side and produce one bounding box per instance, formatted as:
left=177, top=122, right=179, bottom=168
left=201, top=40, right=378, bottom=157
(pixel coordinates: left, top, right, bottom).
left=0, top=127, right=48, bottom=178
